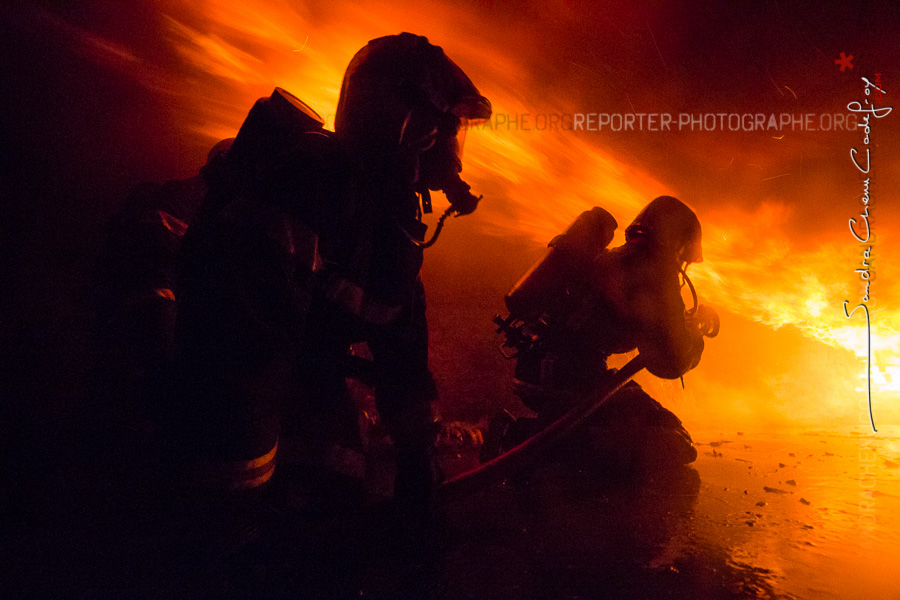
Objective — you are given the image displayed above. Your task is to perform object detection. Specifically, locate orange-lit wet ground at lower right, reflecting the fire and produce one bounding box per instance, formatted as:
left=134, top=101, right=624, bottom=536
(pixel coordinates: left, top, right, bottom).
left=690, top=427, right=900, bottom=598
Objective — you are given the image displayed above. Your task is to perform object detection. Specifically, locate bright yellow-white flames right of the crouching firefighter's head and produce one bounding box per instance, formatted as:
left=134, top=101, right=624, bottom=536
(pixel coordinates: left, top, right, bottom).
left=695, top=203, right=900, bottom=394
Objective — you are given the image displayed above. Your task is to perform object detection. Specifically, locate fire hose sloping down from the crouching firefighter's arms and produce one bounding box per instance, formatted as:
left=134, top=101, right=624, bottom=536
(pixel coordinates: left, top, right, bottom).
left=436, top=354, right=645, bottom=501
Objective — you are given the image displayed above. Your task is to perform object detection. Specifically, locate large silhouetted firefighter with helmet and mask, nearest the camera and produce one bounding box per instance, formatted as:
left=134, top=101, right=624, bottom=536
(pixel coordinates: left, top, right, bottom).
left=169, top=33, right=491, bottom=520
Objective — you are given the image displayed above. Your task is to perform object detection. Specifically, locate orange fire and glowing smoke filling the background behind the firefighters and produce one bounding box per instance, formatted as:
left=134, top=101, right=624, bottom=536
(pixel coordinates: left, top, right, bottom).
left=58, top=0, right=900, bottom=425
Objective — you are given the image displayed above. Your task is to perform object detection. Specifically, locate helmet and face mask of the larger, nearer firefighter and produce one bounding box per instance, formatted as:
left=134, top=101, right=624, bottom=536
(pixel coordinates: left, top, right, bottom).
left=334, top=33, right=491, bottom=196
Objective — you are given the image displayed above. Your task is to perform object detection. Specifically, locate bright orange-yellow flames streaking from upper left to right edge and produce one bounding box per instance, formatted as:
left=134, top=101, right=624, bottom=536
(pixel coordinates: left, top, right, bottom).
left=70, top=0, right=900, bottom=422
